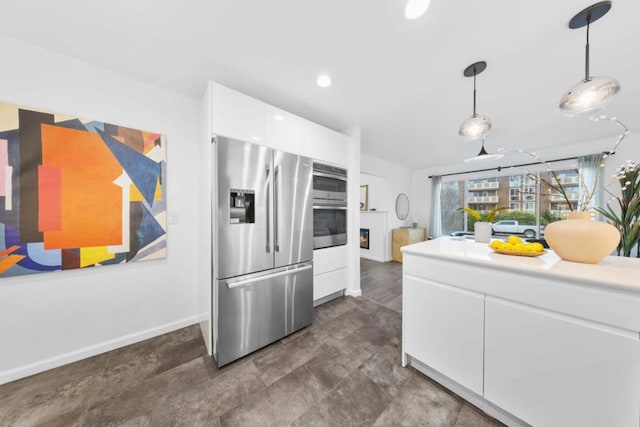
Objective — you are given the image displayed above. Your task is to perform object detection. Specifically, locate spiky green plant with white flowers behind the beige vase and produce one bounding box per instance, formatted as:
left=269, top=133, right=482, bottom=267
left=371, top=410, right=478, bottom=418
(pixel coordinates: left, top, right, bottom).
left=596, top=161, right=640, bottom=258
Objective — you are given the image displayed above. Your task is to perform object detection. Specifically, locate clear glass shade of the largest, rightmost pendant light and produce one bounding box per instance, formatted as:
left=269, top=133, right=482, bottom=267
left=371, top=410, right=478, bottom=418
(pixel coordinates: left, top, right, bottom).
left=560, top=76, right=620, bottom=117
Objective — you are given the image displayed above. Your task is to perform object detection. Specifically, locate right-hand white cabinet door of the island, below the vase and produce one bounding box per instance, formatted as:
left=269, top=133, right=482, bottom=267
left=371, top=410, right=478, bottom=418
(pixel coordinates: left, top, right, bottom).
left=484, top=297, right=640, bottom=427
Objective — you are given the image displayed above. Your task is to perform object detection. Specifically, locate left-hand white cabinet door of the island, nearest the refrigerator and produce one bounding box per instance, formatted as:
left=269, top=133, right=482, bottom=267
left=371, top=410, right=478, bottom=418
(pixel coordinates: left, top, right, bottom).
left=402, top=275, right=484, bottom=395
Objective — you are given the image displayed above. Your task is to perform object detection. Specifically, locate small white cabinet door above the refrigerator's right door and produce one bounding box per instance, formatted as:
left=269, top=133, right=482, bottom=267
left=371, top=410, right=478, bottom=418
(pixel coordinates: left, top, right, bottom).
left=265, top=105, right=306, bottom=155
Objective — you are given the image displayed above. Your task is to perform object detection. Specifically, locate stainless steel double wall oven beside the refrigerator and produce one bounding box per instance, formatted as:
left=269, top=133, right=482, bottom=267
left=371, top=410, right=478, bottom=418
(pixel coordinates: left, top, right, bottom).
left=313, top=163, right=347, bottom=249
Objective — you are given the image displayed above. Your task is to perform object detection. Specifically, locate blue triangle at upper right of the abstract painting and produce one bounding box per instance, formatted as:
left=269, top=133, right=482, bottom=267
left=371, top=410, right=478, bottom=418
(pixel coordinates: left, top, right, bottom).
left=97, top=129, right=160, bottom=206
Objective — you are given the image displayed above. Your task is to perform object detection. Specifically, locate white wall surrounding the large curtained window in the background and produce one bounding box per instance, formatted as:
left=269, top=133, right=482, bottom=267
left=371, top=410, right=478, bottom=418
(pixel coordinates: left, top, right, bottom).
left=411, top=131, right=640, bottom=235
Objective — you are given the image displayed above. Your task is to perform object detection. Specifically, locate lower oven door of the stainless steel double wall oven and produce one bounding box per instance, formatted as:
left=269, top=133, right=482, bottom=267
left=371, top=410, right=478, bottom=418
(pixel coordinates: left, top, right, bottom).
left=313, top=205, right=347, bottom=249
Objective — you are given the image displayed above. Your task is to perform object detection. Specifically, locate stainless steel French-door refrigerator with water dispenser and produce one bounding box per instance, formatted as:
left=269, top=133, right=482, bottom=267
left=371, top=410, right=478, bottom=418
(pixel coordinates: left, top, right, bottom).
left=212, top=137, right=313, bottom=366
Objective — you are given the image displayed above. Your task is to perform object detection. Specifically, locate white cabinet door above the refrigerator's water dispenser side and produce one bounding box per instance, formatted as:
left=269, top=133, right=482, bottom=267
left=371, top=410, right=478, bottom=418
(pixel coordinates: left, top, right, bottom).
left=210, top=82, right=265, bottom=144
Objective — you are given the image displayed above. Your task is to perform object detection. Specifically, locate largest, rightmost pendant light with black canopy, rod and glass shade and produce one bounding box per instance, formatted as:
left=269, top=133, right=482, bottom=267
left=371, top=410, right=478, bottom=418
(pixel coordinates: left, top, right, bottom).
left=560, top=1, right=620, bottom=117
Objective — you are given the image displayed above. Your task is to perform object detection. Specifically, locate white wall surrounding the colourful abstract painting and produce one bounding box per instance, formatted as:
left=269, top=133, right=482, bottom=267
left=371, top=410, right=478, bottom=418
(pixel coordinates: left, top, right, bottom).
left=0, top=37, right=202, bottom=383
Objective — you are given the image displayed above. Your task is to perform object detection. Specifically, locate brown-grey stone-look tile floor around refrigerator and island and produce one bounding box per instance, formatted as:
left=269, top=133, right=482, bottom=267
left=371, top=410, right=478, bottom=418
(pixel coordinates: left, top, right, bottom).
left=0, top=262, right=499, bottom=427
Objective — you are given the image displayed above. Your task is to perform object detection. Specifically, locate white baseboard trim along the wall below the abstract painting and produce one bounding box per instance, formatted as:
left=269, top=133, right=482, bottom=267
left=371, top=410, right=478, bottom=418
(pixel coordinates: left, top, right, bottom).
left=0, top=314, right=206, bottom=385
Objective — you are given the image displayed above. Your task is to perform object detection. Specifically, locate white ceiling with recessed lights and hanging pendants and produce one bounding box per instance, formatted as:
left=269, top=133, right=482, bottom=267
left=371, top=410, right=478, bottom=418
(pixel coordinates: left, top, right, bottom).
left=0, top=0, right=640, bottom=168
